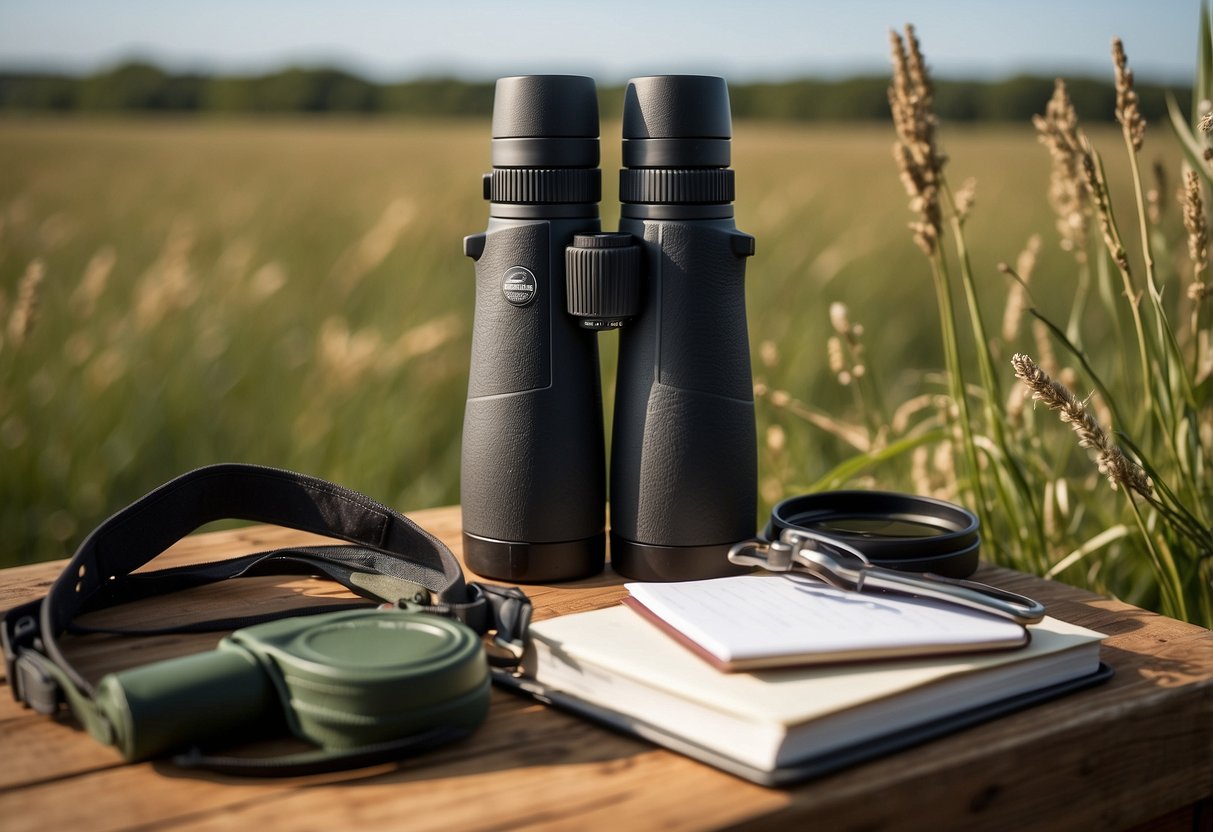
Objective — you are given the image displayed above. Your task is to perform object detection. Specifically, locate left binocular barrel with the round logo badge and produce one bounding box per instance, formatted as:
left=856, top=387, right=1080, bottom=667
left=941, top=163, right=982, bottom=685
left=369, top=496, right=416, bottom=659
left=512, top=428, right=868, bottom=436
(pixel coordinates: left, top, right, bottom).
left=461, top=75, right=607, bottom=581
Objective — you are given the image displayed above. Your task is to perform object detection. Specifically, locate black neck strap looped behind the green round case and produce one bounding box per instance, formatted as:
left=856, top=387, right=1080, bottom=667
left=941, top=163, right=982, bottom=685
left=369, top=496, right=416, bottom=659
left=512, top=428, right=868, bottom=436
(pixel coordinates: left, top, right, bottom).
left=2, top=463, right=530, bottom=712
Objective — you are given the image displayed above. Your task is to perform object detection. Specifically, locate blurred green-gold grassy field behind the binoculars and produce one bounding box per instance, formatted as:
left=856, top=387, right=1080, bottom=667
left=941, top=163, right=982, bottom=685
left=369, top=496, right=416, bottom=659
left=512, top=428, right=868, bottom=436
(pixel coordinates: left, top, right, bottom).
left=0, top=117, right=1181, bottom=596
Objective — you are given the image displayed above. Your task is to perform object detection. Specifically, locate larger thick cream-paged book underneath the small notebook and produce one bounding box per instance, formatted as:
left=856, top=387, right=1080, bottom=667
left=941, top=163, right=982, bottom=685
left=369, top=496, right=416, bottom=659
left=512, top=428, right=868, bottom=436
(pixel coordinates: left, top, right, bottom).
left=495, top=605, right=1111, bottom=785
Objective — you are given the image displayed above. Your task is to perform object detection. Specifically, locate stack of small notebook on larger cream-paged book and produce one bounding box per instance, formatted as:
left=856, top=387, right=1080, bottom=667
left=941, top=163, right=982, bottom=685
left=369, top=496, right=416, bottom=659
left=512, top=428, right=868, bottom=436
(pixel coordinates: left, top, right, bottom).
left=497, top=576, right=1111, bottom=785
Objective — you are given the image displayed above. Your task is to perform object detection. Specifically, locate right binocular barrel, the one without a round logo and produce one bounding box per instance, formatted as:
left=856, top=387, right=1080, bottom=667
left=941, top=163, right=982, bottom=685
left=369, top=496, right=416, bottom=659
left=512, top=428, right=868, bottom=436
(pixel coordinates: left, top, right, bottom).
left=610, top=75, right=758, bottom=581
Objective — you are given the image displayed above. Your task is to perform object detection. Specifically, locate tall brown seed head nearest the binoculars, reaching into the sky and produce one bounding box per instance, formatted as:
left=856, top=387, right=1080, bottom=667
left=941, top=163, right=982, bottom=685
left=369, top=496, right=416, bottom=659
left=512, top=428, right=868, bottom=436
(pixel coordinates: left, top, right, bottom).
left=889, top=25, right=945, bottom=256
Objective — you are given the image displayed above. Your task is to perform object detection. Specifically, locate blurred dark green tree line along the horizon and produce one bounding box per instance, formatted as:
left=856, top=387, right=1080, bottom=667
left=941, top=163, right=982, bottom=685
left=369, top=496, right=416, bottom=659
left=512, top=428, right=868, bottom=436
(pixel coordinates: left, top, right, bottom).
left=0, top=63, right=1191, bottom=121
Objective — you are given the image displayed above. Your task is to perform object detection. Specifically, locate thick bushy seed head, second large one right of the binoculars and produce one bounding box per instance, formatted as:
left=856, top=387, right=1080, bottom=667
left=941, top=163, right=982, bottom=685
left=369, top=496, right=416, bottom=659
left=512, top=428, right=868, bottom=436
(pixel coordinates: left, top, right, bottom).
left=1032, top=78, right=1090, bottom=262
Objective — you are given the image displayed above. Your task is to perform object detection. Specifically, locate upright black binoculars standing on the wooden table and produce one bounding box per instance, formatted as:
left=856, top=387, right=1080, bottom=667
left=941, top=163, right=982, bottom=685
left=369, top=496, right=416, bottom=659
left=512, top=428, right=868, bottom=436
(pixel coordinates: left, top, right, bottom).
left=461, top=75, right=757, bottom=582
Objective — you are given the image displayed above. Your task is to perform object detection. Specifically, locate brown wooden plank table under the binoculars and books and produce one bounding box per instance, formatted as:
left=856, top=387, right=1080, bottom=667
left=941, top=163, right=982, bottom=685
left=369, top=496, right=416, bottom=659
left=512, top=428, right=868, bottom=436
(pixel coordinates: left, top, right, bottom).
left=0, top=507, right=1213, bottom=832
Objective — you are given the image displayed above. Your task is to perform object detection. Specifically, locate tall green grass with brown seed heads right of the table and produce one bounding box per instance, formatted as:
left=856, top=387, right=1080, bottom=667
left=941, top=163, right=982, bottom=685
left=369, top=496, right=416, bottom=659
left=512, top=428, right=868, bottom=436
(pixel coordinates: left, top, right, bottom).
left=771, top=19, right=1213, bottom=626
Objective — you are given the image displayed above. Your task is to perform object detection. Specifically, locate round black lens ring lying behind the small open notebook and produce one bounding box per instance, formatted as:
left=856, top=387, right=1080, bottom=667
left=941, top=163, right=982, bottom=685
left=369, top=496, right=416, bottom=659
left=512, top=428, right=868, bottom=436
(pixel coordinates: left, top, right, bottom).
left=763, top=491, right=981, bottom=579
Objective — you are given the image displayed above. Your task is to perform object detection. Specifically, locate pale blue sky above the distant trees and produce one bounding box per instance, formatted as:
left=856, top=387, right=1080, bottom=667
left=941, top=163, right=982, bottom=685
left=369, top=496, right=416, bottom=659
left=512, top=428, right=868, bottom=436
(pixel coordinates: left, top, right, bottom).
left=0, top=0, right=1200, bottom=82
